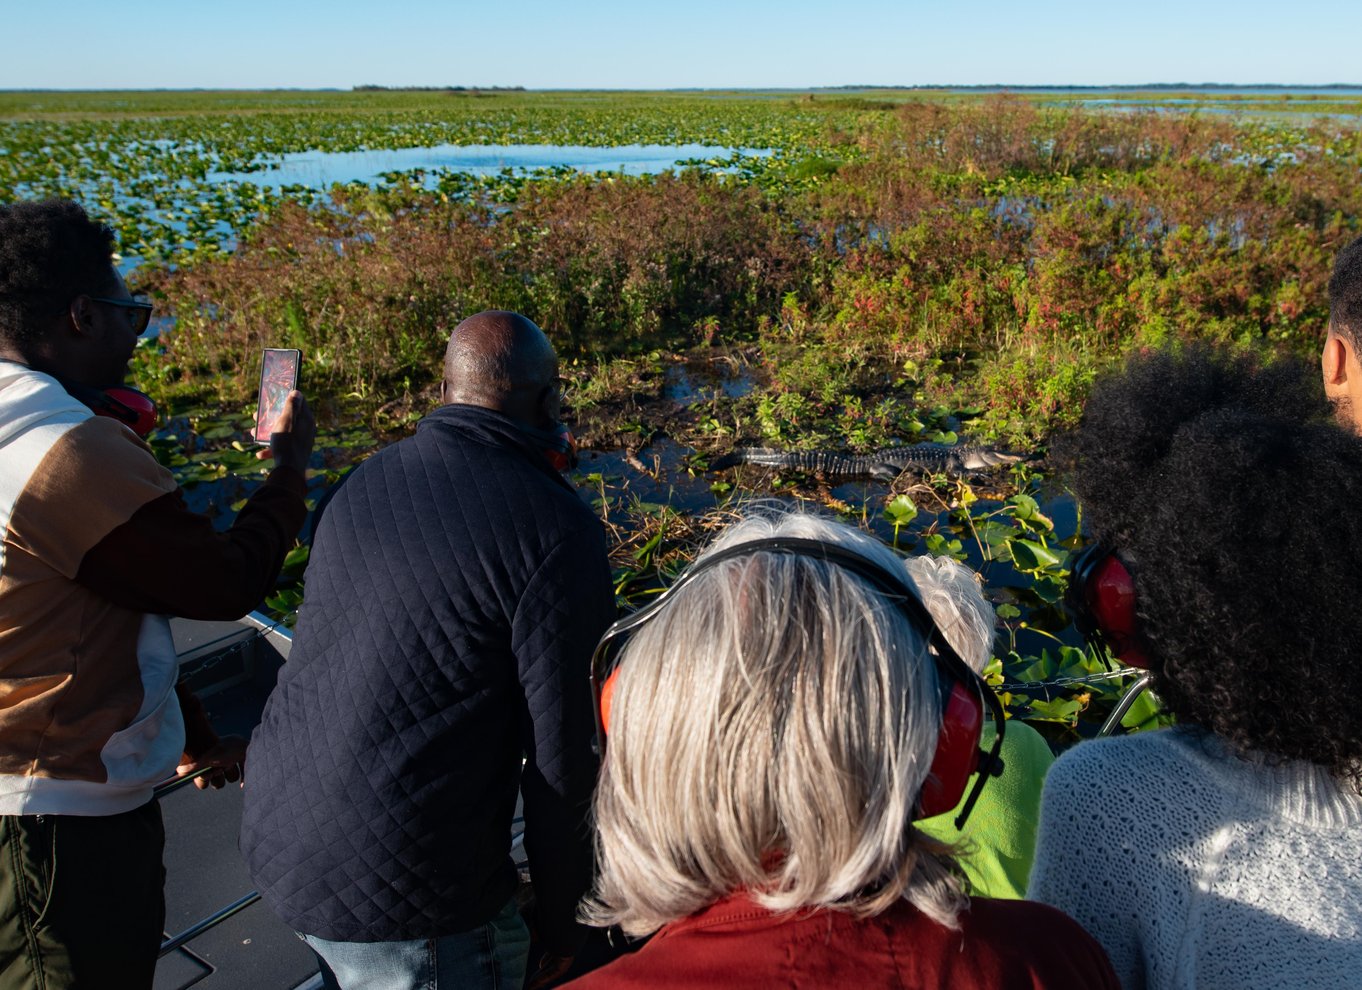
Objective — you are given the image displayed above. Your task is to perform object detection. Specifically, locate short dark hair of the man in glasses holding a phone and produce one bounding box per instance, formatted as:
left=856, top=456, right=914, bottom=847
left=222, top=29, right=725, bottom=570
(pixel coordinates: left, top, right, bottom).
left=0, top=199, right=114, bottom=345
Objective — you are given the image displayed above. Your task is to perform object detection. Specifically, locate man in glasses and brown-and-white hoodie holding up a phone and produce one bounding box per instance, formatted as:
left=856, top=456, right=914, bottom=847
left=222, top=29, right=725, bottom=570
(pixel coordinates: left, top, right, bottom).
left=0, top=200, right=315, bottom=987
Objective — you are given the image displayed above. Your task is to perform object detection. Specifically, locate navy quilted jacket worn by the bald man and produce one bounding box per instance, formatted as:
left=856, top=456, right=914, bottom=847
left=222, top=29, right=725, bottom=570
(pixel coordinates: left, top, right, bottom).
left=241, top=406, right=614, bottom=951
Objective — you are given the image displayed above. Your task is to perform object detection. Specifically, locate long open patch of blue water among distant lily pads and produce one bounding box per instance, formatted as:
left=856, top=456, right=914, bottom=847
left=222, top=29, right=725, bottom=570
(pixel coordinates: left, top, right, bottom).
left=210, top=144, right=771, bottom=189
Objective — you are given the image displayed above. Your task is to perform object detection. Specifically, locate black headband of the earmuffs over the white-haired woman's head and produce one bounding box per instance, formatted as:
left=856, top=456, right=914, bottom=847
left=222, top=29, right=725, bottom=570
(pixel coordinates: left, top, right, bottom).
left=591, top=537, right=1007, bottom=828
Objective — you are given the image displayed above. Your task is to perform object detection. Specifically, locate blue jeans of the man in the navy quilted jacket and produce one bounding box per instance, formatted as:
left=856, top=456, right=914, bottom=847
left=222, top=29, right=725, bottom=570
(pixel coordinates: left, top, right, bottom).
left=300, top=897, right=530, bottom=990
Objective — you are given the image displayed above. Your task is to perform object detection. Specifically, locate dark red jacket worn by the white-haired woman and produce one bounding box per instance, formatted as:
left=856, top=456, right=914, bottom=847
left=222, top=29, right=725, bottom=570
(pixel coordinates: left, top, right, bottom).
left=568, top=895, right=1121, bottom=990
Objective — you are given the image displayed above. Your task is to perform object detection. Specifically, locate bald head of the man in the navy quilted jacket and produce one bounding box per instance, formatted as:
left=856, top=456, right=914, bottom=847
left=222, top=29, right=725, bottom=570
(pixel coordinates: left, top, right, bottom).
left=441, top=309, right=558, bottom=426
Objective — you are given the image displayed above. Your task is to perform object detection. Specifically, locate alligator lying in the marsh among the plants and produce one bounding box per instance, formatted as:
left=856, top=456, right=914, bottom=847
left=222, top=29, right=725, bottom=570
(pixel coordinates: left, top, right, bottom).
left=710, top=444, right=1022, bottom=481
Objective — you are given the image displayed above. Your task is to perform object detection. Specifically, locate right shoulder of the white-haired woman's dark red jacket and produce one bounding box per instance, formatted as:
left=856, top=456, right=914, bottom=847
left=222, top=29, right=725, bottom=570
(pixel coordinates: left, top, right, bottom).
left=959, top=897, right=1120, bottom=990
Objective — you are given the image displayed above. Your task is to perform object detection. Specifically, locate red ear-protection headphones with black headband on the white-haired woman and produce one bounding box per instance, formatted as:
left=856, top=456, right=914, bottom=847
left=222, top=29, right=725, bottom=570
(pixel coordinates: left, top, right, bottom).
left=591, top=537, right=1005, bottom=828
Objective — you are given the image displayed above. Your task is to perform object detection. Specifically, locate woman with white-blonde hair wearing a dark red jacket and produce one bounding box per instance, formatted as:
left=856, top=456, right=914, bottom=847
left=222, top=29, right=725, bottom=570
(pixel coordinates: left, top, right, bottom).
left=563, top=513, right=1117, bottom=990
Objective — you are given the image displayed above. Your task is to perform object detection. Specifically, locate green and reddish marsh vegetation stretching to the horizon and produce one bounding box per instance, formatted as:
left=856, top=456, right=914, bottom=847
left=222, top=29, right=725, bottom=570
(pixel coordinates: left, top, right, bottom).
left=0, top=90, right=1362, bottom=741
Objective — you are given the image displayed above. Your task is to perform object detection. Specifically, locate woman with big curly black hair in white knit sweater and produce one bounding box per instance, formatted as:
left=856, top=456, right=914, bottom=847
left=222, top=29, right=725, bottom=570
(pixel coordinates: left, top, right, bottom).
left=1030, top=347, right=1362, bottom=990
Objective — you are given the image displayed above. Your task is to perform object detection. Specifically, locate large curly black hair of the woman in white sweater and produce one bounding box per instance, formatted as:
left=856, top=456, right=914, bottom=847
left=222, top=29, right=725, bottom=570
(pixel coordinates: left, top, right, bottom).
left=1057, top=346, right=1362, bottom=786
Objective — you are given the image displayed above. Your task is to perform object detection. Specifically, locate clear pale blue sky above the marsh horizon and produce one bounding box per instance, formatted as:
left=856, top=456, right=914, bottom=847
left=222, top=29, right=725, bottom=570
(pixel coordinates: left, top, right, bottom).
left=0, top=0, right=1362, bottom=89
